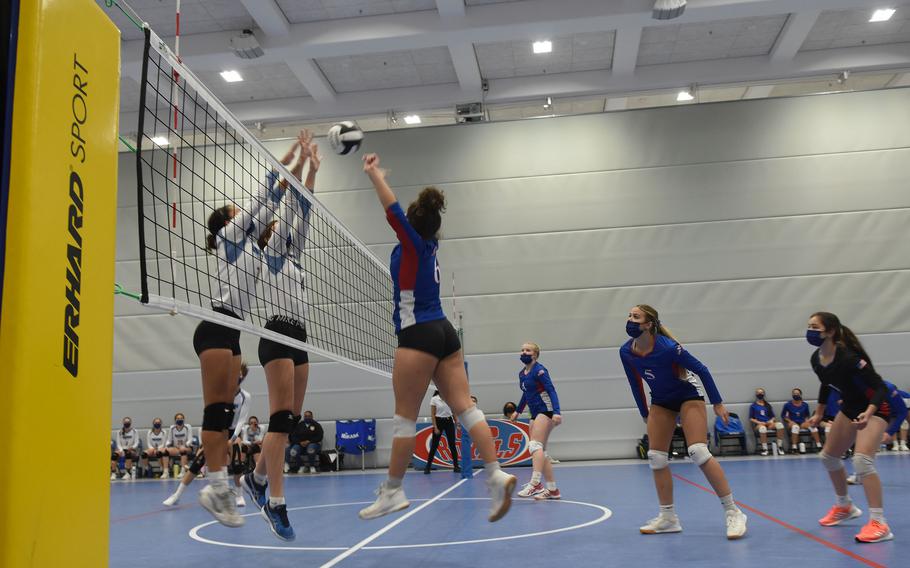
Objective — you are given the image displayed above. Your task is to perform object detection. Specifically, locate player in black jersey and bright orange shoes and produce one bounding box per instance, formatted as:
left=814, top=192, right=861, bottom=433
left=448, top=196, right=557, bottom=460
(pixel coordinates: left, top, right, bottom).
left=806, top=312, right=894, bottom=542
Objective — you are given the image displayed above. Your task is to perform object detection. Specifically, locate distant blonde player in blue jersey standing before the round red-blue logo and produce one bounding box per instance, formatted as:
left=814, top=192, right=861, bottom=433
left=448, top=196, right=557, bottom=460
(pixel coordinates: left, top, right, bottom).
left=510, top=341, right=562, bottom=500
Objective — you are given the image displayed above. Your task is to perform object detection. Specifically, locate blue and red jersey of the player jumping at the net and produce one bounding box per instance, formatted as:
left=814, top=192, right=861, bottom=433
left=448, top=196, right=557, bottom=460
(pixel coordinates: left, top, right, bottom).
left=386, top=201, right=446, bottom=334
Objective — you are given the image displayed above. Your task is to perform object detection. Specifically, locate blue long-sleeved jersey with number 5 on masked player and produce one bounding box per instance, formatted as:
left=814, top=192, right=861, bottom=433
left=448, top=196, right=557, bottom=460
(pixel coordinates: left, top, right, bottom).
left=619, top=335, right=723, bottom=417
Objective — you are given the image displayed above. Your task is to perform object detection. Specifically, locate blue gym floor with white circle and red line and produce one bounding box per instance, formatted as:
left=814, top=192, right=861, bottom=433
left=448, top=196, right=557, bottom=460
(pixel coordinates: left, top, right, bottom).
left=110, top=452, right=910, bottom=568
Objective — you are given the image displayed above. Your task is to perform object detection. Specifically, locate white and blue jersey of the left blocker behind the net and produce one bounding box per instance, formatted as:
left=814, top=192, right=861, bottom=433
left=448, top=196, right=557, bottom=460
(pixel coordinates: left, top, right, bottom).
left=212, top=172, right=283, bottom=319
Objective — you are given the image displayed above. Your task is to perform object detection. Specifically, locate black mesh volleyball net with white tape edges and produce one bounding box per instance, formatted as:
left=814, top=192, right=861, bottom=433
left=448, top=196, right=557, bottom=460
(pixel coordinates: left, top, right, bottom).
left=136, top=29, right=396, bottom=376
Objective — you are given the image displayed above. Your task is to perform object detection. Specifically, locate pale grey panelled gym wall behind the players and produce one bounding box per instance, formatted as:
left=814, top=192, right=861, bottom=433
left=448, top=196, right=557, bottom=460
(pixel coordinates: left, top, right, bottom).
left=112, top=89, right=910, bottom=464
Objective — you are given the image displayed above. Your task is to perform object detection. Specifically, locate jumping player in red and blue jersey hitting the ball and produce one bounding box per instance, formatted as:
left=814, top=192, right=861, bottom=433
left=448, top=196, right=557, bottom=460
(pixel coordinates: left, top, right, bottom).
left=360, top=154, right=517, bottom=522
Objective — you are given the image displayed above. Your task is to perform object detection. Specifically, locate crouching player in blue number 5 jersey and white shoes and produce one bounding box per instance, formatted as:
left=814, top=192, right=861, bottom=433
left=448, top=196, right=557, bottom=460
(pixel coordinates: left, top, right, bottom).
left=619, top=304, right=746, bottom=540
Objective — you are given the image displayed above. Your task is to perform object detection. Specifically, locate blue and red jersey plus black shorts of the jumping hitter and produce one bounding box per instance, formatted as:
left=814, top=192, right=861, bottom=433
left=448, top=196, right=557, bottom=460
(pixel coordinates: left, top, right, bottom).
left=386, top=201, right=461, bottom=359
